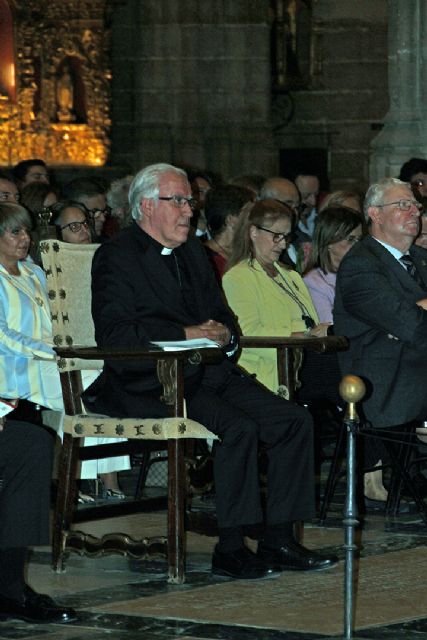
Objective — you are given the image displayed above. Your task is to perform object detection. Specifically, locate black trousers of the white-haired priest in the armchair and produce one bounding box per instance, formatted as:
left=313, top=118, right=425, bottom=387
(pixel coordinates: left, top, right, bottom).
left=187, top=368, right=314, bottom=527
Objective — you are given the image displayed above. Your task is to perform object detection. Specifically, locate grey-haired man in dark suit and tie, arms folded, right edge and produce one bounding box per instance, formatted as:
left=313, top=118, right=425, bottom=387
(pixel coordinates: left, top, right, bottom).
left=334, top=178, right=427, bottom=500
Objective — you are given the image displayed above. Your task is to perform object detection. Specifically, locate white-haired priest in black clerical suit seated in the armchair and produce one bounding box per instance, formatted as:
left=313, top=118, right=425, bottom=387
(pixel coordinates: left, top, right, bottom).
left=86, top=164, right=337, bottom=578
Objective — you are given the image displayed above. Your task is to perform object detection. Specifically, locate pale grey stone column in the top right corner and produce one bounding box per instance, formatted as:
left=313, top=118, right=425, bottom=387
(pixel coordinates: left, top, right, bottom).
left=370, top=0, right=427, bottom=181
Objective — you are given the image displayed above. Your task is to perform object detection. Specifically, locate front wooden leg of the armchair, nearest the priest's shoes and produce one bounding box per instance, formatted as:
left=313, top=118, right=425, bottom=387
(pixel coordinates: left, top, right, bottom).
left=168, top=440, right=186, bottom=584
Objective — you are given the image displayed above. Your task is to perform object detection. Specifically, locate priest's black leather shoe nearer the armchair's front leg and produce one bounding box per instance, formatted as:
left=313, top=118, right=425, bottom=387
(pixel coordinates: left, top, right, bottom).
left=212, top=545, right=279, bottom=580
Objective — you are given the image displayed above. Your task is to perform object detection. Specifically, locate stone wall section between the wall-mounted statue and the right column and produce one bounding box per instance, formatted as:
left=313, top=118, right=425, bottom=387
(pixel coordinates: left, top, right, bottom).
left=276, top=0, right=388, bottom=189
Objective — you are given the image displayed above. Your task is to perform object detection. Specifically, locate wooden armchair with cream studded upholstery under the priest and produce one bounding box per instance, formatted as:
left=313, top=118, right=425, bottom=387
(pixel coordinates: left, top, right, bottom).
left=40, top=240, right=222, bottom=583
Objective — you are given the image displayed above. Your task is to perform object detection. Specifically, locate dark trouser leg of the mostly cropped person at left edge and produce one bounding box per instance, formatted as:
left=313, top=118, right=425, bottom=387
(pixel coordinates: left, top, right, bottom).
left=0, top=420, right=53, bottom=549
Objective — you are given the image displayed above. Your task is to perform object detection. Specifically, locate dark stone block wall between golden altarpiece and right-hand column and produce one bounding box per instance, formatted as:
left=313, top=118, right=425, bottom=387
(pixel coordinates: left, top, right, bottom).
left=111, top=0, right=388, bottom=188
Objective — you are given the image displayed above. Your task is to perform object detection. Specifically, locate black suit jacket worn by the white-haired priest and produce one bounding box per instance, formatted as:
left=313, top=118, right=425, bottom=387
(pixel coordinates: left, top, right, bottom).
left=84, top=223, right=237, bottom=417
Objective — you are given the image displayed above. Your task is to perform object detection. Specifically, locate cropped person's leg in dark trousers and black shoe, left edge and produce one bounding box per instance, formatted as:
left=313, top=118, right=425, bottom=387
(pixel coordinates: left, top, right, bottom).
left=0, top=418, right=76, bottom=624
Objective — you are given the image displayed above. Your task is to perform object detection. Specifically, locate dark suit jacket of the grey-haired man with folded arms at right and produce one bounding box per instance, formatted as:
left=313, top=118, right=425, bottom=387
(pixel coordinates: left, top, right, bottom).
left=334, top=236, right=427, bottom=427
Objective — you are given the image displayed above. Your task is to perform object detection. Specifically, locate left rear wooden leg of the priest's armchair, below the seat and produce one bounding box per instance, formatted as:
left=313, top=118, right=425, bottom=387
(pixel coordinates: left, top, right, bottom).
left=52, top=433, right=80, bottom=573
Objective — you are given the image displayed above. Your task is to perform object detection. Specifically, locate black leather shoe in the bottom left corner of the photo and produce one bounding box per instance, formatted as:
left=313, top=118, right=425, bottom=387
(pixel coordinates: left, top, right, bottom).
left=0, top=586, right=77, bottom=624
